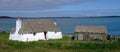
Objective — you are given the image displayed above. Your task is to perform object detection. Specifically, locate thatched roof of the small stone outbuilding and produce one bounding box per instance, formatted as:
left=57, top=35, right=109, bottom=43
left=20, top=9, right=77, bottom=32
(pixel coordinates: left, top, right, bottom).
left=75, top=26, right=107, bottom=33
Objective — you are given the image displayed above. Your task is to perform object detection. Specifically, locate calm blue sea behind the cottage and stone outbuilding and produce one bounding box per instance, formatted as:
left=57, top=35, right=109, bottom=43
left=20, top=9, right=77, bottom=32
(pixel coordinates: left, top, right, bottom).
left=0, top=18, right=120, bottom=35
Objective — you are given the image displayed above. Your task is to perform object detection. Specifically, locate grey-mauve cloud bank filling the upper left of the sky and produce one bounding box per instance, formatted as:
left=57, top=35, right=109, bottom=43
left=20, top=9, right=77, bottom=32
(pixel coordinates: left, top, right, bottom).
left=0, top=0, right=91, bottom=11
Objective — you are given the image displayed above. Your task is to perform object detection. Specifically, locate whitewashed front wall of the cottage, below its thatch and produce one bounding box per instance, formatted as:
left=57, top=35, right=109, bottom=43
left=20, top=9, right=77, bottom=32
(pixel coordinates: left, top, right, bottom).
left=9, top=31, right=62, bottom=42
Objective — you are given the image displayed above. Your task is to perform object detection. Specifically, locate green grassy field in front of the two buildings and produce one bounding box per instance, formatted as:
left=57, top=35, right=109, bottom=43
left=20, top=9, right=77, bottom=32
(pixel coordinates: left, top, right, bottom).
left=0, top=33, right=120, bottom=52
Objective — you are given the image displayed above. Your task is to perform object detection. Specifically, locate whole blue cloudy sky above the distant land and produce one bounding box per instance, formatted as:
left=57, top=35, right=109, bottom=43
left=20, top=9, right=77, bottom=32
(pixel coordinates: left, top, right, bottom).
left=0, top=0, right=120, bottom=17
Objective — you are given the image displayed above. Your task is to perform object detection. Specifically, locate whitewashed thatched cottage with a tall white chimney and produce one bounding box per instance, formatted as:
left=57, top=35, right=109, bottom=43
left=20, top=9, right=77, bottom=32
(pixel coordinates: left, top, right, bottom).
left=9, top=17, right=62, bottom=42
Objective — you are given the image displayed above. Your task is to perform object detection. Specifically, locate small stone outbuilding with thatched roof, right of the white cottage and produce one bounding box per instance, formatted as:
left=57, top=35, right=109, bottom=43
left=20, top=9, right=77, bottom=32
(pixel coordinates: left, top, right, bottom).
left=75, top=26, right=107, bottom=40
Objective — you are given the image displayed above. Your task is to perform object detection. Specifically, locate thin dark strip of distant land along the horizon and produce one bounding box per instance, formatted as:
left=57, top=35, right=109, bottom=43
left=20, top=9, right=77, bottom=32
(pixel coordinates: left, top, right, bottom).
left=0, top=16, right=120, bottom=19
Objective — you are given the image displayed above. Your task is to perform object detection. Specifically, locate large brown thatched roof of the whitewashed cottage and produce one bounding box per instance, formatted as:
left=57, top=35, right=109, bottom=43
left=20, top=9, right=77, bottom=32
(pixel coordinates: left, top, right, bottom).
left=11, top=19, right=60, bottom=34
